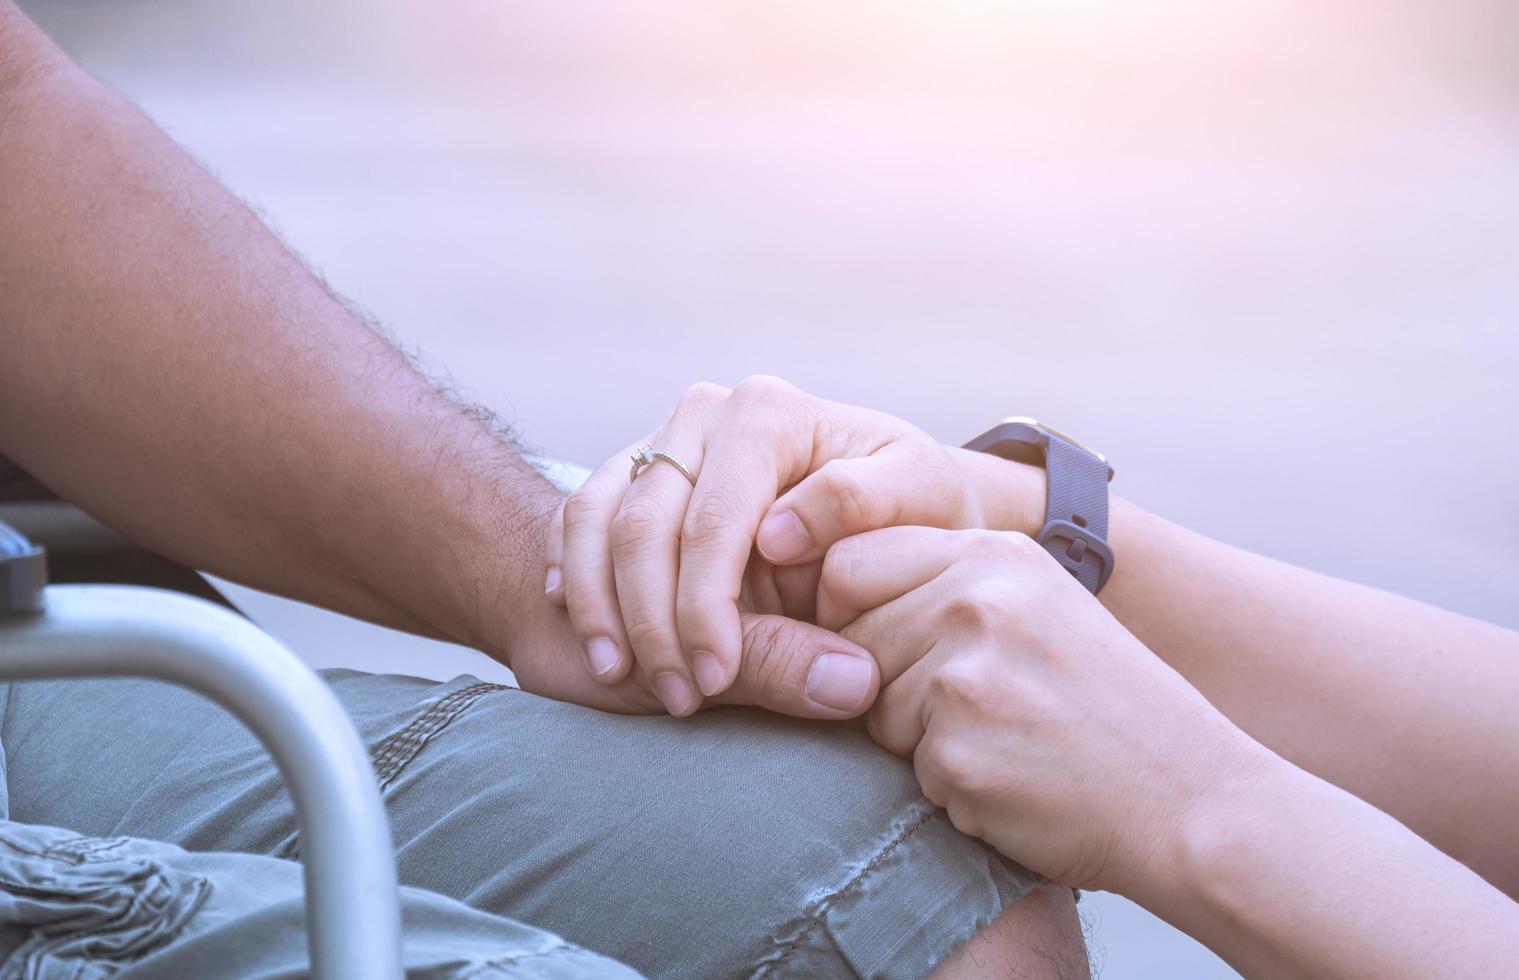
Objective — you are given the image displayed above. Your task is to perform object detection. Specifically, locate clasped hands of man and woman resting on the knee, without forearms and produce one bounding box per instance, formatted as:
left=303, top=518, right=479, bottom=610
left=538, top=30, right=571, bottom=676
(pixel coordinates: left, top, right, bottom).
left=545, top=377, right=1258, bottom=887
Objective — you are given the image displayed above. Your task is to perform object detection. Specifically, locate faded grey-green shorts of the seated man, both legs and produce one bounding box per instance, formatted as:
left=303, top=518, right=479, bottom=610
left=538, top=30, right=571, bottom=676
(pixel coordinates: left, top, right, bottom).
left=0, top=534, right=1037, bottom=980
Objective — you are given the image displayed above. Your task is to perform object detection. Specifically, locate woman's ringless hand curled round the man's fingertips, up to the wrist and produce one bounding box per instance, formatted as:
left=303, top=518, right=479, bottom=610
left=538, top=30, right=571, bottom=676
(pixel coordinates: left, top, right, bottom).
left=817, top=527, right=1274, bottom=890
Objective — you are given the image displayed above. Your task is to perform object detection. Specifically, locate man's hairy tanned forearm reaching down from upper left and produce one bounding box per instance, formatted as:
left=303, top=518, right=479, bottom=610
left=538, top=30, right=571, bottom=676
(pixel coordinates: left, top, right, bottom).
left=0, top=5, right=559, bottom=653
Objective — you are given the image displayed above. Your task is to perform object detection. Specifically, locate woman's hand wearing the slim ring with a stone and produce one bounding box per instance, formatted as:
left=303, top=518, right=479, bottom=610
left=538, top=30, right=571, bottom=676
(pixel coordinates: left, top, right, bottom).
left=545, top=377, right=1001, bottom=717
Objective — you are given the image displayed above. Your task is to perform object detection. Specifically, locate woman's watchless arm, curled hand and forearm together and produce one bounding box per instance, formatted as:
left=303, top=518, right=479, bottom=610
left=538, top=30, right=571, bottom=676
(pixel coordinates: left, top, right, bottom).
left=819, top=527, right=1519, bottom=978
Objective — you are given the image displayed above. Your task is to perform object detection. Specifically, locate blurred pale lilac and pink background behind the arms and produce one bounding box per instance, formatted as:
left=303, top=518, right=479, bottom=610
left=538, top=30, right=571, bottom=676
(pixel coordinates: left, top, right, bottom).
left=23, top=0, right=1519, bottom=980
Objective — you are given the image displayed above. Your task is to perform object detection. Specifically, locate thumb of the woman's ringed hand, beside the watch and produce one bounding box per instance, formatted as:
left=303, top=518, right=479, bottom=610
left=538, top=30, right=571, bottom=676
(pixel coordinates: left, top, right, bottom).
left=756, top=439, right=980, bottom=565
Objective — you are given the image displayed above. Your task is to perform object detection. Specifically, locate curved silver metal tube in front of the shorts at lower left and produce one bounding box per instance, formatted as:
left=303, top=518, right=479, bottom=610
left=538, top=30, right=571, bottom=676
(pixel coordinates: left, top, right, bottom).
left=0, top=585, right=401, bottom=980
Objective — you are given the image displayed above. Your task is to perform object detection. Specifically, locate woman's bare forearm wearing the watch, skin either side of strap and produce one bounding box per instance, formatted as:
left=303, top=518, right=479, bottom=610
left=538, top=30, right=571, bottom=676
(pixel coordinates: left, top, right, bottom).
left=960, top=453, right=1519, bottom=893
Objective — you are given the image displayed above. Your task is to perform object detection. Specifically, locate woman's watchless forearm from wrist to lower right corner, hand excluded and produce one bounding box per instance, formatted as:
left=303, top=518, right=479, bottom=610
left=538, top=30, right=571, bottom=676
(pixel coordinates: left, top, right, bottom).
left=1126, top=752, right=1519, bottom=980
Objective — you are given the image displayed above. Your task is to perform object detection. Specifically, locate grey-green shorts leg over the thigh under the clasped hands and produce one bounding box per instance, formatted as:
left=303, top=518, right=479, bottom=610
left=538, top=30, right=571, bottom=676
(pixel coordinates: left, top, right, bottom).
left=0, top=672, right=1036, bottom=977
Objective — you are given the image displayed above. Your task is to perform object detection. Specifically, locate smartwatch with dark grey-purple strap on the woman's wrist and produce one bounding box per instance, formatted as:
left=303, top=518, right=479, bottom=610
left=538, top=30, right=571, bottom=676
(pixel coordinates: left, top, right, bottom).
left=962, top=418, right=1113, bottom=596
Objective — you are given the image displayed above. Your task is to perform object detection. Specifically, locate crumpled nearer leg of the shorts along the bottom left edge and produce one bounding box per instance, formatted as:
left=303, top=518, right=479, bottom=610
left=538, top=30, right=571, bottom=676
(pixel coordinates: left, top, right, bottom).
left=0, top=820, right=636, bottom=980
